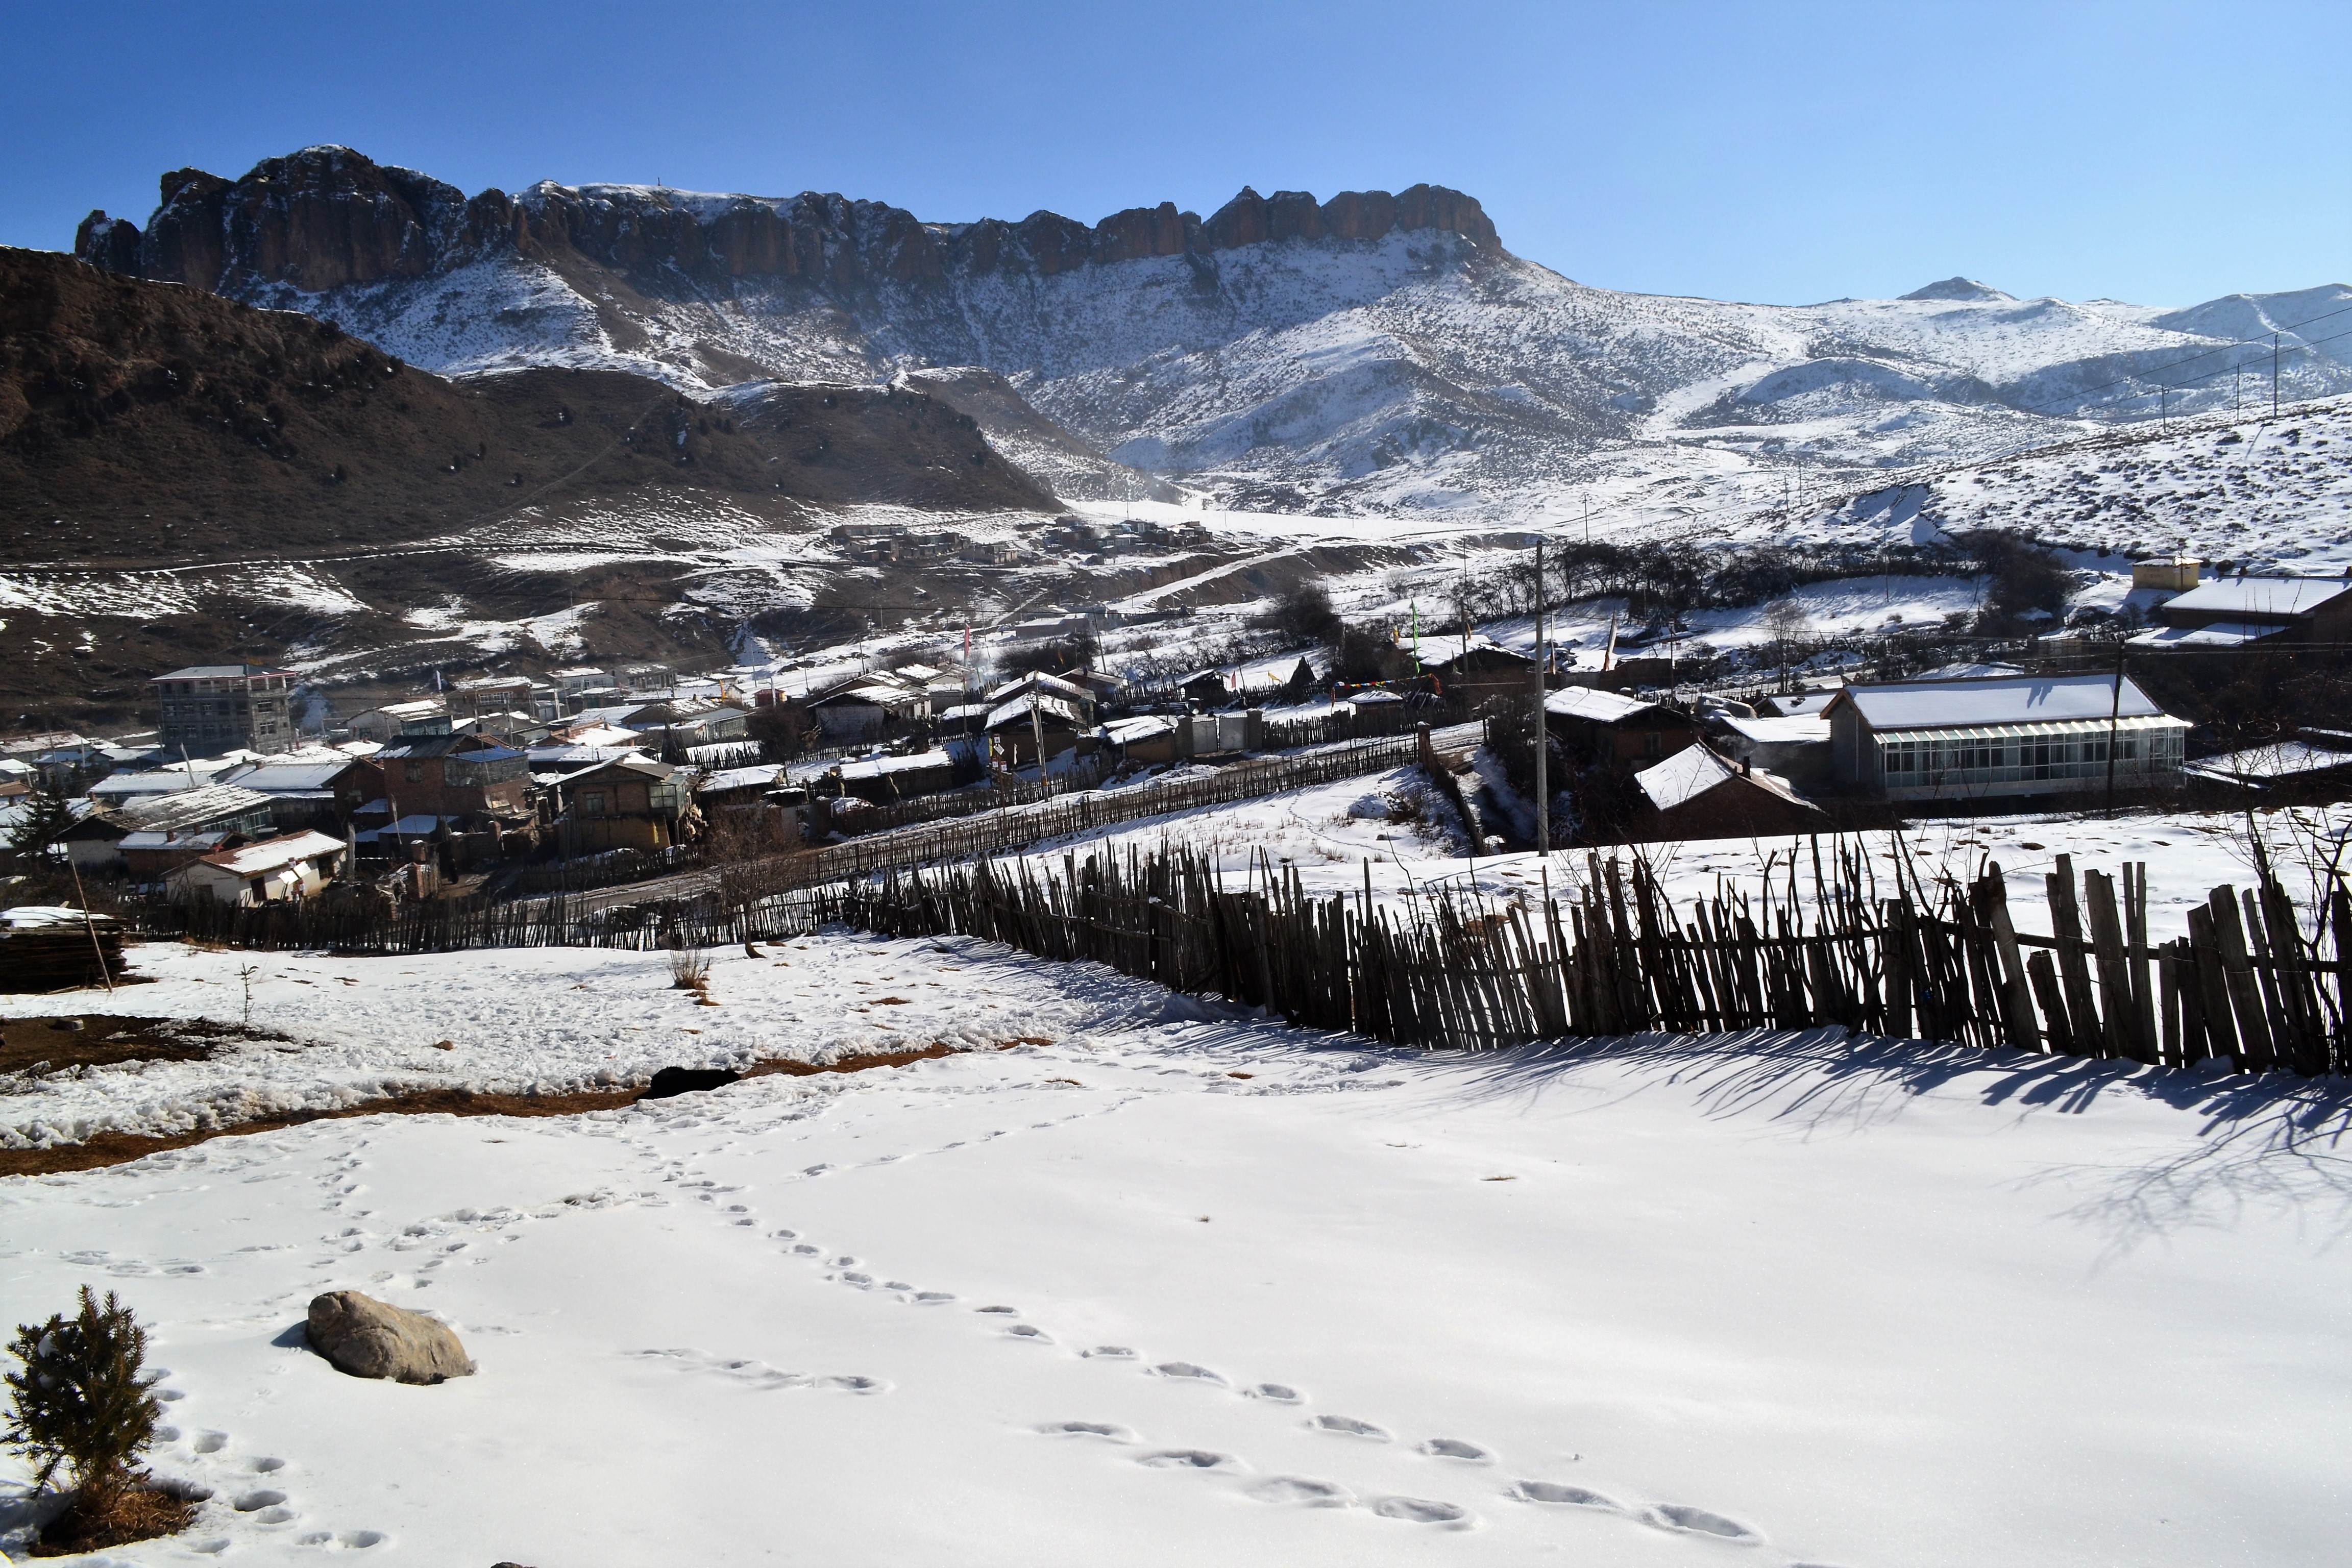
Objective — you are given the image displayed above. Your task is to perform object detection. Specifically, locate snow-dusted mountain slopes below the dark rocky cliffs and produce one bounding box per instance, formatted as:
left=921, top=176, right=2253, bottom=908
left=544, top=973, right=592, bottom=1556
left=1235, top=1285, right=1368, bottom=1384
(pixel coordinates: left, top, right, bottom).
left=244, top=193, right=2352, bottom=517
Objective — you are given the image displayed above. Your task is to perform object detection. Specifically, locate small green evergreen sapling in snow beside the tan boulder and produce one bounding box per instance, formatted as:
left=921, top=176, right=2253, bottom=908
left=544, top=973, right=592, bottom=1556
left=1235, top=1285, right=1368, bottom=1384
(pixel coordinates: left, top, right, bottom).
left=0, top=1286, right=162, bottom=1509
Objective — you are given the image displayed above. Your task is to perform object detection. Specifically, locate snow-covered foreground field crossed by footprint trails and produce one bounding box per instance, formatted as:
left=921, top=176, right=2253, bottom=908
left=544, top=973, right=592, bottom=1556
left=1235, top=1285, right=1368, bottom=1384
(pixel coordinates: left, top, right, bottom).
left=0, top=936, right=2352, bottom=1568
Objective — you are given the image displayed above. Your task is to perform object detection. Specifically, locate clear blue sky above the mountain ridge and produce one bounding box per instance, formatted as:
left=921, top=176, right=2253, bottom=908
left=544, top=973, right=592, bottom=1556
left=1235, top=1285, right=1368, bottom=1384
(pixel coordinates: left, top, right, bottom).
left=0, top=0, right=2352, bottom=303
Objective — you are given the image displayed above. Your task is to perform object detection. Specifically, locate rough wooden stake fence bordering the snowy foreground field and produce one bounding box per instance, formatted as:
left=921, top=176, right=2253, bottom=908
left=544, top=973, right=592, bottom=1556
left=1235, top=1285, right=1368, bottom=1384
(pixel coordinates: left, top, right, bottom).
left=146, top=839, right=2352, bottom=1074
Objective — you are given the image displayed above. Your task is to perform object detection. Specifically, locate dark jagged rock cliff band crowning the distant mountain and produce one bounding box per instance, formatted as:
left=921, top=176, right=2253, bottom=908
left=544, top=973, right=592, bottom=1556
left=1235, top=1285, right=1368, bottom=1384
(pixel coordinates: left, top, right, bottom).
left=73, top=146, right=1501, bottom=294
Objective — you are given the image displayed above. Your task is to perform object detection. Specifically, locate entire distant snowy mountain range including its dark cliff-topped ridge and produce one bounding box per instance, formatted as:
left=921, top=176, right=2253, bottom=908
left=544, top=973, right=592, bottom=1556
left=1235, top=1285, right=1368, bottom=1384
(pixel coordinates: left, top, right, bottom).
left=78, top=148, right=2352, bottom=520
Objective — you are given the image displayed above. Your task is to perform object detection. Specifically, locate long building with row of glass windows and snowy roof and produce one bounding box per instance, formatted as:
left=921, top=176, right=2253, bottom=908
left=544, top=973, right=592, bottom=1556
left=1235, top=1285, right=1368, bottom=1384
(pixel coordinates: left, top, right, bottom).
left=1823, top=675, right=2190, bottom=799
